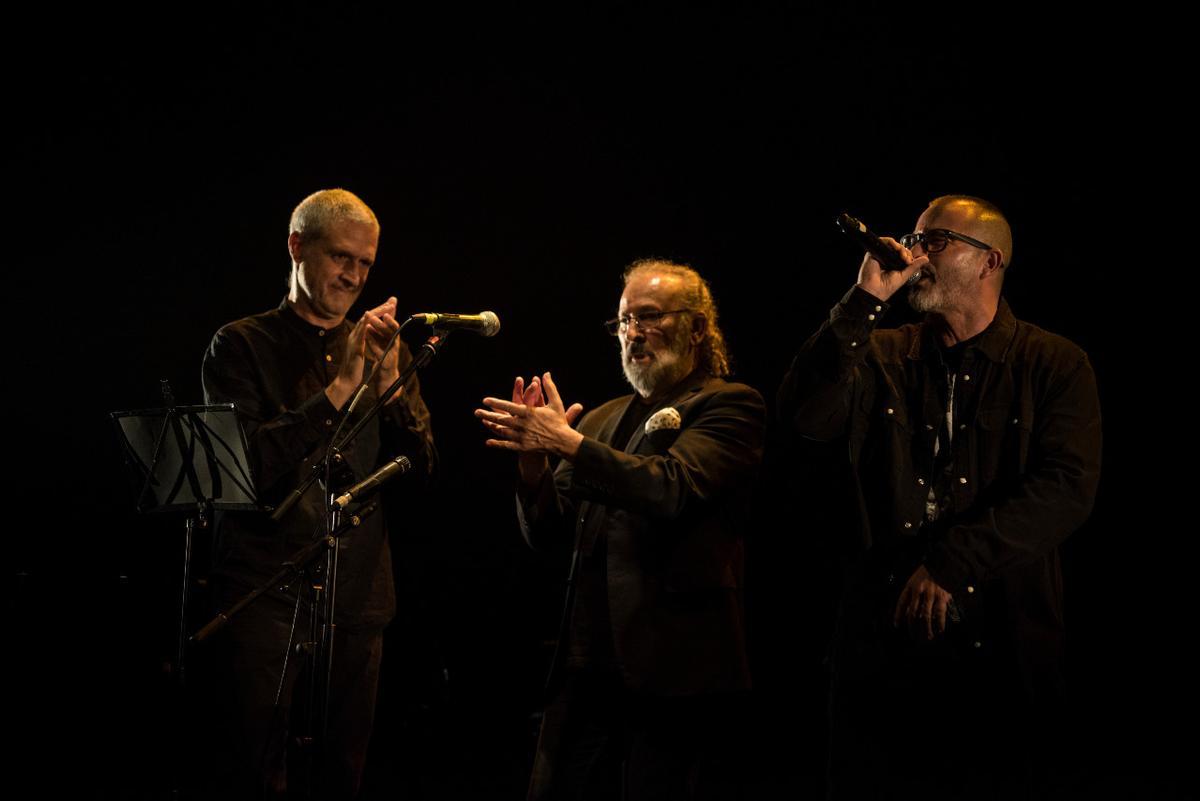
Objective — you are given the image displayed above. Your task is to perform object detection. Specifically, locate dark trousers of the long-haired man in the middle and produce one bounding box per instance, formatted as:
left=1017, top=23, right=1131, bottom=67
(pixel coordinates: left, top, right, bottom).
left=528, top=670, right=745, bottom=801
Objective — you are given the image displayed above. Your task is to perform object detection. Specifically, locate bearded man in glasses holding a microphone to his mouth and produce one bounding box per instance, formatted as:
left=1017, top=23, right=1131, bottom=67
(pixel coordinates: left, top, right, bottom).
left=779, top=195, right=1100, bottom=799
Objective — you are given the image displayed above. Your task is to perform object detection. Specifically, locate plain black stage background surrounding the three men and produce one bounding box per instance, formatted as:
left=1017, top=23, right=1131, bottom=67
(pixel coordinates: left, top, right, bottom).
left=5, top=4, right=1195, bottom=799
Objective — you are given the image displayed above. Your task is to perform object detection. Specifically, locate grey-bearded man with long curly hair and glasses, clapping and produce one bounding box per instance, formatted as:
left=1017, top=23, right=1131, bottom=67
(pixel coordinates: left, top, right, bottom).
left=475, top=260, right=766, bottom=801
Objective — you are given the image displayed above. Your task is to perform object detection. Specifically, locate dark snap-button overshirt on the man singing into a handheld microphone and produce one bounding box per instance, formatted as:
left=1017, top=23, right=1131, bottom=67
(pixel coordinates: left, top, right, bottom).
left=779, top=287, right=1100, bottom=660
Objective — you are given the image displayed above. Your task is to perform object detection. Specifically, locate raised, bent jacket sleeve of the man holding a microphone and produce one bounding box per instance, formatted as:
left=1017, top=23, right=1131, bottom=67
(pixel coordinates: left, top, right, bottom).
left=776, top=285, right=888, bottom=441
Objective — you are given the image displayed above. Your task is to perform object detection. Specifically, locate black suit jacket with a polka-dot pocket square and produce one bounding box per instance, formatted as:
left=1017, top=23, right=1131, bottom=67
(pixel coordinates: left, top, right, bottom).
left=521, top=372, right=766, bottom=695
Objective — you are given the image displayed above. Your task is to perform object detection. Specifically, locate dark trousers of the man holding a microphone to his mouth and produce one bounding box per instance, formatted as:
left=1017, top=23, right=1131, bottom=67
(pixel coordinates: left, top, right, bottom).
left=829, top=631, right=1064, bottom=801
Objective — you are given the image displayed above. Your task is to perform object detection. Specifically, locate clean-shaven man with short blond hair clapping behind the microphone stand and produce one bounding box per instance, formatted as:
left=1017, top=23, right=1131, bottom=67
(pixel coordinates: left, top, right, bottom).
left=203, top=189, right=434, bottom=799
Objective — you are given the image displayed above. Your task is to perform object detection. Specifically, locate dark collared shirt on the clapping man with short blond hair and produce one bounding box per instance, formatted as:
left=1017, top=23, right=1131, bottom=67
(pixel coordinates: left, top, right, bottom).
left=203, top=300, right=436, bottom=626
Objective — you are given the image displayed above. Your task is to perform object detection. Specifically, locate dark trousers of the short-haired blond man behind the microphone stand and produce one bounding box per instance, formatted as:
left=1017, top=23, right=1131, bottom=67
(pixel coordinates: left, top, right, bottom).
left=214, top=597, right=383, bottom=800
